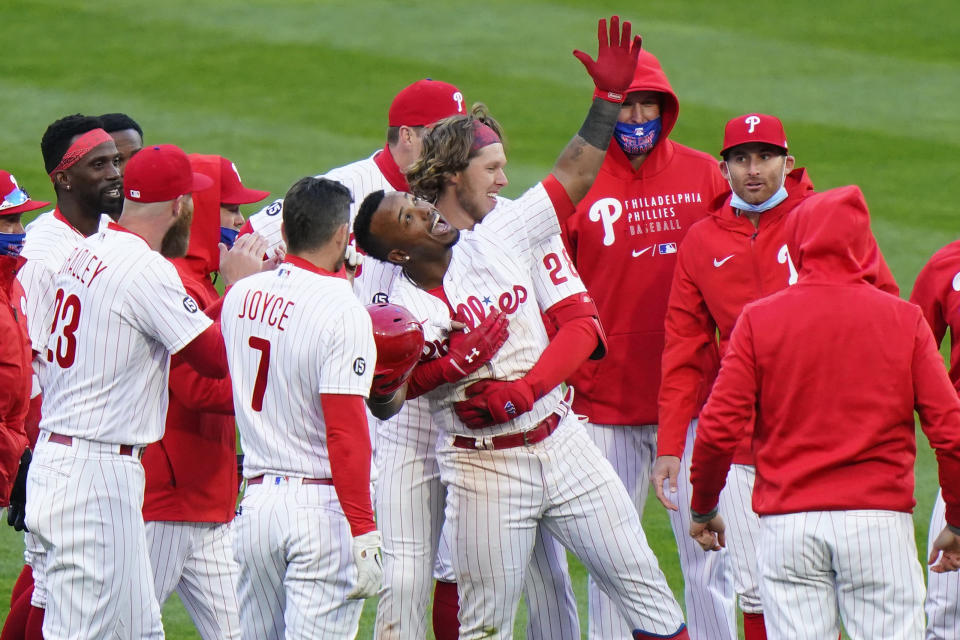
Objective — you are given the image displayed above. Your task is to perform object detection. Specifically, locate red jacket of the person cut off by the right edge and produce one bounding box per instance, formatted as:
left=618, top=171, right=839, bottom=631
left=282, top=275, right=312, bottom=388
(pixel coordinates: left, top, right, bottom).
left=910, top=240, right=960, bottom=391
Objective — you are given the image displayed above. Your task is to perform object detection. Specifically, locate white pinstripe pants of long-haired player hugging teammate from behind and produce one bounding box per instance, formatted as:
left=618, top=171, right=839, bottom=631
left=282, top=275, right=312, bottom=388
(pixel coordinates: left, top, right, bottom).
left=374, top=424, right=580, bottom=640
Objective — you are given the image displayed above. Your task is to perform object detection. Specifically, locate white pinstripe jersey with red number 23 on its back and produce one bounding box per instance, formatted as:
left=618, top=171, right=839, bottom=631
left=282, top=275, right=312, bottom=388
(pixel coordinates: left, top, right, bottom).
left=40, top=224, right=211, bottom=445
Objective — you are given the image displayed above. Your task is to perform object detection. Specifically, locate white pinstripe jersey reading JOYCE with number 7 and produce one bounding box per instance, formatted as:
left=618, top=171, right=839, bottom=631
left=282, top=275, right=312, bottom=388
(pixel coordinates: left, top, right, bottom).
left=221, top=257, right=377, bottom=478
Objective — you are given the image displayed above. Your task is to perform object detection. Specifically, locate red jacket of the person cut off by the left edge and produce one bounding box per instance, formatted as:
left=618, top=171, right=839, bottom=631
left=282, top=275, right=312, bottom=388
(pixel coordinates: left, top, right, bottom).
left=0, top=256, right=33, bottom=507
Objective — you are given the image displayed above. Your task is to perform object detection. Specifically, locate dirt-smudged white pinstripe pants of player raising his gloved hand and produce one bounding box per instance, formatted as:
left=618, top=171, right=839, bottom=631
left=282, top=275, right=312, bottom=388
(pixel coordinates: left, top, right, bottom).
left=437, top=413, right=683, bottom=640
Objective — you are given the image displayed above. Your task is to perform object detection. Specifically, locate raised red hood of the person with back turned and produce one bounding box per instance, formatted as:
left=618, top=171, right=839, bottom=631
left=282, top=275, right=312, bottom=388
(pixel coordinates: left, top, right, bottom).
left=784, top=185, right=881, bottom=285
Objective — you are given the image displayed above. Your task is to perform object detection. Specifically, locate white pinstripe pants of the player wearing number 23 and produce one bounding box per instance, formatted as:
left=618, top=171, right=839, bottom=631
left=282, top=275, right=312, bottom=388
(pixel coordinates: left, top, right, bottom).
left=27, top=431, right=164, bottom=640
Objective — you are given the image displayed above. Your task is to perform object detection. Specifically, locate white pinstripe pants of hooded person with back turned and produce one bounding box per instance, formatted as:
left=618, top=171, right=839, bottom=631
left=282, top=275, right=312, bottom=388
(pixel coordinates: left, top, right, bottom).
left=758, top=510, right=924, bottom=640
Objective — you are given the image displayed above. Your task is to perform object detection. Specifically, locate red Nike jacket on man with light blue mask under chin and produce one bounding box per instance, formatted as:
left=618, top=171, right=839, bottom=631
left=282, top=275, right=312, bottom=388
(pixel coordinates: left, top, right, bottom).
left=657, top=169, right=899, bottom=464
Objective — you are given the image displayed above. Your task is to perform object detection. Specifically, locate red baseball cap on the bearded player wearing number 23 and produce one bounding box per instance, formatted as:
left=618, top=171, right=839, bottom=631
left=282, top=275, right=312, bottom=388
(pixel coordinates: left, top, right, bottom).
left=123, top=144, right=213, bottom=202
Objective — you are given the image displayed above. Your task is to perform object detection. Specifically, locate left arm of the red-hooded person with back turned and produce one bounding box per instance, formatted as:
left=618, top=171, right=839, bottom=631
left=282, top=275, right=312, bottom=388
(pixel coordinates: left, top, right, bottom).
left=690, top=312, right=759, bottom=549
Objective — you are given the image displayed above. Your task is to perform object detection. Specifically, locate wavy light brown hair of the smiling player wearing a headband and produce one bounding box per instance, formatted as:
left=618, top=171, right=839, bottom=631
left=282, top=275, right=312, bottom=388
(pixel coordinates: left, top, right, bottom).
left=406, top=102, right=504, bottom=203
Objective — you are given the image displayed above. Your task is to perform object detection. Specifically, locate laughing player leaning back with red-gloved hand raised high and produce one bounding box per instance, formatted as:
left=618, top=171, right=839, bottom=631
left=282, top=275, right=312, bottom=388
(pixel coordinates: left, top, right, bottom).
left=354, top=17, right=687, bottom=638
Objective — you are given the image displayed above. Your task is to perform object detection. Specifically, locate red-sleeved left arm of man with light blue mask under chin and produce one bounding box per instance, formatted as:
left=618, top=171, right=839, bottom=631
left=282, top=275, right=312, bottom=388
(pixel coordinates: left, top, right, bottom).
left=651, top=242, right=719, bottom=511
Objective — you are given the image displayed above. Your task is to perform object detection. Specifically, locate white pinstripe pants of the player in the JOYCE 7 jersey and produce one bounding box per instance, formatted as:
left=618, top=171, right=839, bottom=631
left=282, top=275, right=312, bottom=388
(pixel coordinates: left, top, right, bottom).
left=233, top=475, right=364, bottom=640
